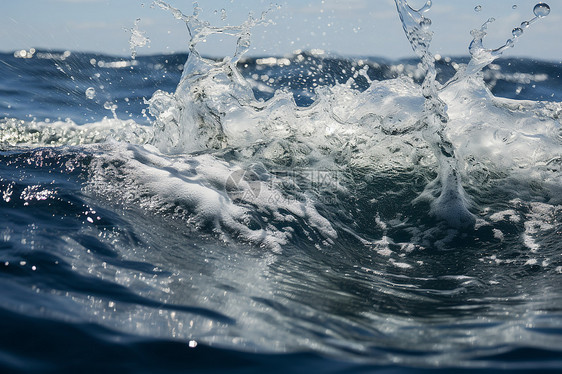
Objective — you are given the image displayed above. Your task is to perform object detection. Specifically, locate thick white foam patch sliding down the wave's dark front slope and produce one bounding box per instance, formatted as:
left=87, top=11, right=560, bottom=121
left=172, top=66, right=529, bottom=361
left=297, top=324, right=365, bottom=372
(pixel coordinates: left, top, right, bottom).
left=86, top=143, right=337, bottom=251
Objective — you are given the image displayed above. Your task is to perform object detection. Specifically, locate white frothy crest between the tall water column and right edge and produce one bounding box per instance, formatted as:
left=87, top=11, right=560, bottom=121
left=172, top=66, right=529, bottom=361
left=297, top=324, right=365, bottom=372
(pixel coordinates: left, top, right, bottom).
left=441, top=76, right=562, bottom=203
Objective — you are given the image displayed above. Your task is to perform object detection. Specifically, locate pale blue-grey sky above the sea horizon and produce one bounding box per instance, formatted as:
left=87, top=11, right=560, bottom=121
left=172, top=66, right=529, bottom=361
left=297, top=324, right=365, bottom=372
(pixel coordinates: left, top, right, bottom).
left=0, top=0, right=562, bottom=62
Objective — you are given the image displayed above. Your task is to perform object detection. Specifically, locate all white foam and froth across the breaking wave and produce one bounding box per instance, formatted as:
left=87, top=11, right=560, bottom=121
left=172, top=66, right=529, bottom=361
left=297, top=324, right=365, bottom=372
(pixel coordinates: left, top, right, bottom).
left=0, top=2, right=562, bottom=254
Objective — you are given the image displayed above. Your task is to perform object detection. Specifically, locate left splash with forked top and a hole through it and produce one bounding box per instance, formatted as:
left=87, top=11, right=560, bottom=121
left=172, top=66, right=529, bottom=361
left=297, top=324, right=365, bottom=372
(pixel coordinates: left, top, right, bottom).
left=149, top=0, right=270, bottom=153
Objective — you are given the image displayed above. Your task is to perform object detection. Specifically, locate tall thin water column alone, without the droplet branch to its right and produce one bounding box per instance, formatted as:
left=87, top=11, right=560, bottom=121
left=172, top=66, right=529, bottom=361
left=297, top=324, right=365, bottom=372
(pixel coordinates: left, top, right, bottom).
left=395, top=0, right=475, bottom=227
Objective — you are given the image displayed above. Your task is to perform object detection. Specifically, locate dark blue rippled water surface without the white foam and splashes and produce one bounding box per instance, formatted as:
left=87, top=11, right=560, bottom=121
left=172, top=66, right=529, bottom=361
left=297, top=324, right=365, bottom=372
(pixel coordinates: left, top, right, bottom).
left=0, top=51, right=562, bottom=373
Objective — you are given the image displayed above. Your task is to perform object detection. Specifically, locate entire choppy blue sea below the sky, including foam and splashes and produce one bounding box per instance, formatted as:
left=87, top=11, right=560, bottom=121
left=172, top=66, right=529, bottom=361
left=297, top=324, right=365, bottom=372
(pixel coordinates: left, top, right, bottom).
left=0, top=0, right=562, bottom=373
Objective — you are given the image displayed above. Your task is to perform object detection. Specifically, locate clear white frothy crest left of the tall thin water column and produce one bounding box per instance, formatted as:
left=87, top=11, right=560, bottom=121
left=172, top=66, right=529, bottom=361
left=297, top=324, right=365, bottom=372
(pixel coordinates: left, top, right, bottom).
left=149, top=27, right=433, bottom=169
